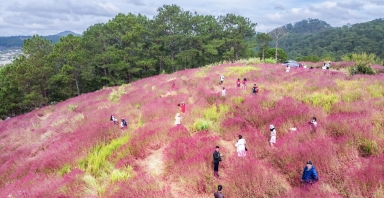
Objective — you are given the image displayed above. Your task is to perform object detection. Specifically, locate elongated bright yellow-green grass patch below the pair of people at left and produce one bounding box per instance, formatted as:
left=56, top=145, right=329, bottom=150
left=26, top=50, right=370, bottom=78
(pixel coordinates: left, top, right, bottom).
left=79, top=135, right=130, bottom=176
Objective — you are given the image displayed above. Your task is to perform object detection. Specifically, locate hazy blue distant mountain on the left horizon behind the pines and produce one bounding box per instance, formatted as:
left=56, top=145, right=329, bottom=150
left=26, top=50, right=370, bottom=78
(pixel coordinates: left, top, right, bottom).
left=0, top=30, right=81, bottom=50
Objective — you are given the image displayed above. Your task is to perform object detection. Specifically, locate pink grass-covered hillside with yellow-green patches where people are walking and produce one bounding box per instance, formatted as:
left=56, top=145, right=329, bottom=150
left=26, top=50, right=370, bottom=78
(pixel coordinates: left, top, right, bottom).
left=0, top=63, right=384, bottom=197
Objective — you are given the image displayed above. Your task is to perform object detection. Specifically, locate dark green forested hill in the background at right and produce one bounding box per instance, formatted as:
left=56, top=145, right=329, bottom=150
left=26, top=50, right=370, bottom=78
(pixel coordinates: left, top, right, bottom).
left=279, top=19, right=384, bottom=61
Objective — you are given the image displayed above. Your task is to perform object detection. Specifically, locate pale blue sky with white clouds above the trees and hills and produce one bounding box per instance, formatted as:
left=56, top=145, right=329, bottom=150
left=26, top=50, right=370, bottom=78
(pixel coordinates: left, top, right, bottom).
left=0, top=0, right=384, bottom=36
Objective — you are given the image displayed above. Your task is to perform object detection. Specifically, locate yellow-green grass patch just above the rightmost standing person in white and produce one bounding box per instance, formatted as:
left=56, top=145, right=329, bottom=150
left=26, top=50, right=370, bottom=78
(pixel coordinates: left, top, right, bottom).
left=302, top=92, right=339, bottom=112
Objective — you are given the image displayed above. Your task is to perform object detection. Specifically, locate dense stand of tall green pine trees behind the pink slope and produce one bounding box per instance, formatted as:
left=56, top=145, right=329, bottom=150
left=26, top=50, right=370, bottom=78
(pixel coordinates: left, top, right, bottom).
left=0, top=5, right=256, bottom=119
